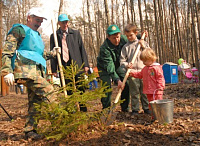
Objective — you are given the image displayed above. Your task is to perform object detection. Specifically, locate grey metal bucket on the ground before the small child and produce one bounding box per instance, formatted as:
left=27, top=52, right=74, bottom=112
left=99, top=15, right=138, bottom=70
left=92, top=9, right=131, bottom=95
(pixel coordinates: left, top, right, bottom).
left=150, top=99, right=174, bottom=124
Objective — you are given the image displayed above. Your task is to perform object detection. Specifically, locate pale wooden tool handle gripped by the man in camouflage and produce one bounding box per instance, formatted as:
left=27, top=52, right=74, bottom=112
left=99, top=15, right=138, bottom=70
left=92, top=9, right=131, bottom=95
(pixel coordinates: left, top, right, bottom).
left=51, top=19, right=67, bottom=97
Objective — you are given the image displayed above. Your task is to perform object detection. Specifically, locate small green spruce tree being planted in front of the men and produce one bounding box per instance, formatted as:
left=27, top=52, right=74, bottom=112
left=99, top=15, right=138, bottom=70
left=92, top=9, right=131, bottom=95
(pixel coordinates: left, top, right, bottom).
left=35, top=62, right=111, bottom=140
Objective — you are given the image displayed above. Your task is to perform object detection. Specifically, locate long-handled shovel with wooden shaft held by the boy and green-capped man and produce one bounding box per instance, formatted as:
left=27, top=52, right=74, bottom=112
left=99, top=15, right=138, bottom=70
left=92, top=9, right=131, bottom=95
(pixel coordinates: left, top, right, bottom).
left=105, top=33, right=145, bottom=125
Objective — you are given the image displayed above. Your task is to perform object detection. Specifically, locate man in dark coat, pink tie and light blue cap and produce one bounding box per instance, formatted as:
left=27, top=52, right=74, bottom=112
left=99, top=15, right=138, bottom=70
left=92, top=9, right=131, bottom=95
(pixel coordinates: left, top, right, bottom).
left=50, top=14, right=89, bottom=111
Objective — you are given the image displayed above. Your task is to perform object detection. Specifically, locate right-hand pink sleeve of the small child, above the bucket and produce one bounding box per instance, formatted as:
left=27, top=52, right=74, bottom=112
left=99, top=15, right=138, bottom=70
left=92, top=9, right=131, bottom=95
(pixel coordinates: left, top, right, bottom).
left=156, top=65, right=165, bottom=90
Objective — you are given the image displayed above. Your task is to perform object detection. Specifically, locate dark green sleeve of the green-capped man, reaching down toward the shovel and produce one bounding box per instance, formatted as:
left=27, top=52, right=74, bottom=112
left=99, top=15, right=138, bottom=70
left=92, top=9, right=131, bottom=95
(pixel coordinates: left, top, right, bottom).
left=100, top=48, right=120, bottom=81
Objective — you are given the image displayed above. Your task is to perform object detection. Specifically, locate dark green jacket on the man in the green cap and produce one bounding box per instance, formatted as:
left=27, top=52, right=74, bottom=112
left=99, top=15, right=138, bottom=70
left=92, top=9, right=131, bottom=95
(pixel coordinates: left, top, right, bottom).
left=97, top=35, right=127, bottom=81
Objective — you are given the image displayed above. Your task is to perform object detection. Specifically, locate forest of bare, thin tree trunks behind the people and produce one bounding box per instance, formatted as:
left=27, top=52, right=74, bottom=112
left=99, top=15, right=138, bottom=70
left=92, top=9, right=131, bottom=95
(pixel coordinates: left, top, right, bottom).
left=0, top=0, right=200, bottom=78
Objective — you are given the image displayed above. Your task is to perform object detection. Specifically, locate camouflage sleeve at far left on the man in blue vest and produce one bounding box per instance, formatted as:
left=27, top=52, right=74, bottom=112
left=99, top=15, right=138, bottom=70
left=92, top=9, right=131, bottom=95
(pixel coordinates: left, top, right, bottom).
left=1, top=26, right=25, bottom=76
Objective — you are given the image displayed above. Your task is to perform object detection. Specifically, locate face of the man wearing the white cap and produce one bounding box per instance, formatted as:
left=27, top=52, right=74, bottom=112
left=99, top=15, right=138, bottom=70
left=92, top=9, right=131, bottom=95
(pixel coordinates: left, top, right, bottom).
left=27, top=16, right=44, bottom=31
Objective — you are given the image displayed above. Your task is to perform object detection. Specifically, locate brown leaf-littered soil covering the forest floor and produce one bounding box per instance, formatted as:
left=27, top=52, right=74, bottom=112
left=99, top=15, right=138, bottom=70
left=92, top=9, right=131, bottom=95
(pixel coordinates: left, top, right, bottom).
left=0, top=83, right=200, bottom=146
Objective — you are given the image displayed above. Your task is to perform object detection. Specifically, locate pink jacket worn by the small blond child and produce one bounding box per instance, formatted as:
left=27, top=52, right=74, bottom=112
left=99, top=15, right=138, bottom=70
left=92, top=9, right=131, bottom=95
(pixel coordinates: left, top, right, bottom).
left=129, top=63, right=165, bottom=94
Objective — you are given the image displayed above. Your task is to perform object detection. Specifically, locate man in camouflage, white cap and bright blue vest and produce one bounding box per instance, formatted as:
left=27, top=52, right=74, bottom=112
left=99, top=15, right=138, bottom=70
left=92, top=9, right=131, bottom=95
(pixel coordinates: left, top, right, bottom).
left=1, top=8, right=56, bottom=140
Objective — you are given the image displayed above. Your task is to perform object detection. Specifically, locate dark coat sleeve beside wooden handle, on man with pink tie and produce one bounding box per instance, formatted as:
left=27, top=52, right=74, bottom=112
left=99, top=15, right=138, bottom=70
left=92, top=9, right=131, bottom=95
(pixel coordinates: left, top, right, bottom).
left=50, top=34, right=58, bottom=73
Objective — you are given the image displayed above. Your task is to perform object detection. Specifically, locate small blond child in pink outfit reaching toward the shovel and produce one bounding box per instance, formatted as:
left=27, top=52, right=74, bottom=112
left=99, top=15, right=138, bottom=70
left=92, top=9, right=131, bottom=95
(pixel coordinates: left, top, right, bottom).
left=129, top=48, right=165, bottom=113
